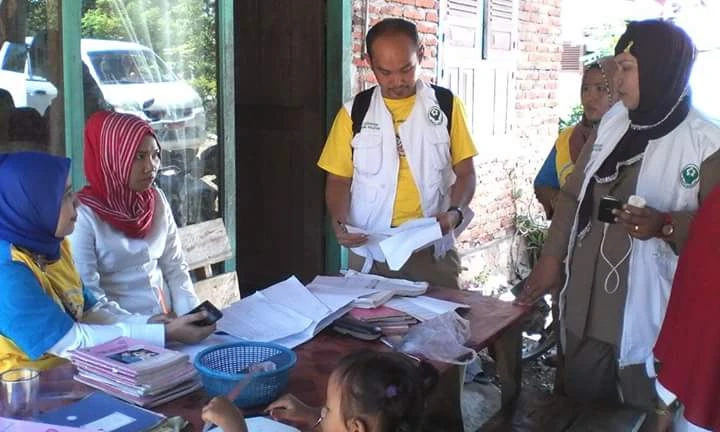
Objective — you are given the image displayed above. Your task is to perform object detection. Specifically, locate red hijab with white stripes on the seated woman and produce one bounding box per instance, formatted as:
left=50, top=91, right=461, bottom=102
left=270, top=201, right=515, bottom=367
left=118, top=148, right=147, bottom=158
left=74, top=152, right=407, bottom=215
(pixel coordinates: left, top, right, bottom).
left=78, top=111, right=157, bottom=238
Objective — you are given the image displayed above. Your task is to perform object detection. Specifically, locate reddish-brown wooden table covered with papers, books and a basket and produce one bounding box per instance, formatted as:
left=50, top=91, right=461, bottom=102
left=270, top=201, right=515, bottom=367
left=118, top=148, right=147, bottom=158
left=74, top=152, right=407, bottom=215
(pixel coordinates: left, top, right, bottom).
left=40, top=288, right=527, bottom=431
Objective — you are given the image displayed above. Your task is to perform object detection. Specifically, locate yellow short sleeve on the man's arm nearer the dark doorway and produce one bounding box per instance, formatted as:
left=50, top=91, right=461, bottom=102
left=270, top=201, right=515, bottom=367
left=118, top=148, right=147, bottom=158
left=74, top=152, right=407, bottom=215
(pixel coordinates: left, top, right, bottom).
left=318, top=107, right=353, bottom=177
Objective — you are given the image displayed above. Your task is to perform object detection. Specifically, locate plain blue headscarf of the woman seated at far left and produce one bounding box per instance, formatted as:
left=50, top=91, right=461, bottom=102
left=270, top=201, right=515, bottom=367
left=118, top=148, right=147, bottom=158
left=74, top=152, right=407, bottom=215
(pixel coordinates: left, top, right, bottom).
left=0, top=152, right=70, bottom=260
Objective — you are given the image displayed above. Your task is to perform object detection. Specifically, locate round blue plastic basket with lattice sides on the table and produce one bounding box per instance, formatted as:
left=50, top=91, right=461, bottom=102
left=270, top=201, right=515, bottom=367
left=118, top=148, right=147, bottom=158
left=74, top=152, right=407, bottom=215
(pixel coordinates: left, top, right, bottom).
left=194, top=342, right=297, bottom=408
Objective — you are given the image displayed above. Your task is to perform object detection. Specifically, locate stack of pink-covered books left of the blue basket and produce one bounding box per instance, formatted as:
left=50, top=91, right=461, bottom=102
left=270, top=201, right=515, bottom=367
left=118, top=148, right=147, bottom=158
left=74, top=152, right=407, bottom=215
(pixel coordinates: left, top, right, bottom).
left=70, top=337, right=202, bottom=407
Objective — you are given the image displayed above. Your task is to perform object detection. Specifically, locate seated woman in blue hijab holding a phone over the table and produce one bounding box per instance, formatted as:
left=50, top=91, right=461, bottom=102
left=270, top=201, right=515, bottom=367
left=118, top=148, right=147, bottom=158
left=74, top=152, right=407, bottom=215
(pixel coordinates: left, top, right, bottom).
left=0, top=152, right=215, bottom=372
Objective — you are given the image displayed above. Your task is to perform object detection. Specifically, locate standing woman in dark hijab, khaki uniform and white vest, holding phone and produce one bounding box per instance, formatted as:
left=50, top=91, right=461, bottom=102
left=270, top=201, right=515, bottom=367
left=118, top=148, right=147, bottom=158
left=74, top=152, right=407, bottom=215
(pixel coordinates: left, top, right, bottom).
left=518, top=20, right=720, bottom=430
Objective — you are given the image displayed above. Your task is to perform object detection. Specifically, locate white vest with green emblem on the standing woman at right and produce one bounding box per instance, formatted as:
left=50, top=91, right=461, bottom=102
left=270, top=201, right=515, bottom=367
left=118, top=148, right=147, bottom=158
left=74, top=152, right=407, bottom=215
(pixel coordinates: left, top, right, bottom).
left=561, top=102, right=720, bottom=367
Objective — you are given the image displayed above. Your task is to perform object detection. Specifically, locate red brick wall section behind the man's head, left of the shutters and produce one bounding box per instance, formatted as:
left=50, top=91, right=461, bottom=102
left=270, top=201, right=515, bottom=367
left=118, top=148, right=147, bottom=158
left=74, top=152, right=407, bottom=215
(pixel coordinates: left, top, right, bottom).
left=352, top=0, right=440, bottom=94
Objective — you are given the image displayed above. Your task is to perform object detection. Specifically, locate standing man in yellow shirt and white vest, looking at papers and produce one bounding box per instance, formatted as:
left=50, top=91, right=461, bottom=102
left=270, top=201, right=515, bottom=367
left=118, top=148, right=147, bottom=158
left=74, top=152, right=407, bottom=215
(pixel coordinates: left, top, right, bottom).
left=318, top=19, right=477, bottom=288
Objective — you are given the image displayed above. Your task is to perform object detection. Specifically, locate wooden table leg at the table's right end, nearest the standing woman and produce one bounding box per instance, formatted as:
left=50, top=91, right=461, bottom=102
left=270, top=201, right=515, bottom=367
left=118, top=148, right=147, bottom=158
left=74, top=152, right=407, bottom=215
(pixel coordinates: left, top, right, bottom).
left=490, top=324, right=522, bottom=408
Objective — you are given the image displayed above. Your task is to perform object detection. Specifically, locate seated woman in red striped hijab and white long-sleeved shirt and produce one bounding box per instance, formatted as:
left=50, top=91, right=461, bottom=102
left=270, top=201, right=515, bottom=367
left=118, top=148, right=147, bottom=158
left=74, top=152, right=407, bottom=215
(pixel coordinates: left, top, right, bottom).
left=70, top=112, right=199, bottom=315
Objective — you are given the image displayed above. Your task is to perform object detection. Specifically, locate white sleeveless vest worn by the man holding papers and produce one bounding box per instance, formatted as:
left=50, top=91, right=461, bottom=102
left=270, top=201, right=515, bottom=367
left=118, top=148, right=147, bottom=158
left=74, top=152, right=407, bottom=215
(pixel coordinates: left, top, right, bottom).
left=345, top=80, right=456, bottom=261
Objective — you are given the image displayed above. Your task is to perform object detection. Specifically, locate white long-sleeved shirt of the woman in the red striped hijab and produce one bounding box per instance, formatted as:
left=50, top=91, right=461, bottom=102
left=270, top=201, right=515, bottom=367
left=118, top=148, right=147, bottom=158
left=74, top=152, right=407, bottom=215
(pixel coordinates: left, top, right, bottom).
left=70, top=188, right=199, bottom=315
